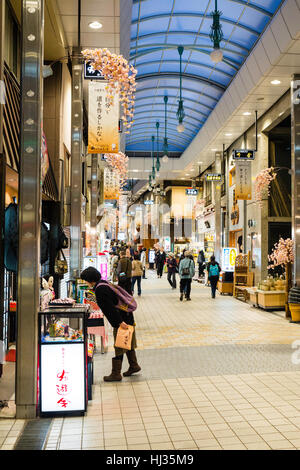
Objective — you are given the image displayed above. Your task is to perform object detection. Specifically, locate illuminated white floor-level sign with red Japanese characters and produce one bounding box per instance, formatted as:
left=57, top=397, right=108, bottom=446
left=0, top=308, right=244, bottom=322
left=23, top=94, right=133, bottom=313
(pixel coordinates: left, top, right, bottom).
left=41, top=343, right=86, bottom=413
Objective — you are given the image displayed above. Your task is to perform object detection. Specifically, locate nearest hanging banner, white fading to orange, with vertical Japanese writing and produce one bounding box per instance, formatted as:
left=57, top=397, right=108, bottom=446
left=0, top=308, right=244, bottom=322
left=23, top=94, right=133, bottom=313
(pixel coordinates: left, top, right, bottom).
left=88, top=81, right=119, bottom=153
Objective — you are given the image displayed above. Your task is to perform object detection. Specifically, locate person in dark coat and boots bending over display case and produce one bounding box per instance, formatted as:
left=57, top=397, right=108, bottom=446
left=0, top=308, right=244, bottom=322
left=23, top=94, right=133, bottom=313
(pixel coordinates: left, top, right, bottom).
left=80, top=266, right=141, bottom=382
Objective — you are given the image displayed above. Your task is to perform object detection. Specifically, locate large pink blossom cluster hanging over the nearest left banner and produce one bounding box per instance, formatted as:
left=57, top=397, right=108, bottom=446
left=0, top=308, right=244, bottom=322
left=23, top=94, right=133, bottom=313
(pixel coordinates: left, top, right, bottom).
left=82, top=48, right=137, bottom=129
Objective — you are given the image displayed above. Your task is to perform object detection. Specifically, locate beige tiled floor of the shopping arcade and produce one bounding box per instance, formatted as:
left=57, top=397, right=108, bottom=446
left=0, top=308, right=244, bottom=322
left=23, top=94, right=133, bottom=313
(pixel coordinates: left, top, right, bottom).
left=0, top=274, right=300, bottom=450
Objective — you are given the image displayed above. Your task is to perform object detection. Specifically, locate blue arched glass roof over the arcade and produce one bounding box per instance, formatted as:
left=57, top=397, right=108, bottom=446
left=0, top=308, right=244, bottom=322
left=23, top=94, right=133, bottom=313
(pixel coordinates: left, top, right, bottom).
left=126, top=0, right=282, bottom=152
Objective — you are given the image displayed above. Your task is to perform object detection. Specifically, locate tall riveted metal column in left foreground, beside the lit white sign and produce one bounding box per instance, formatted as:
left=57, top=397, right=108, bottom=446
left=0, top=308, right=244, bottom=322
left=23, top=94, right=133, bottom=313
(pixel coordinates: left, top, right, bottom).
left=16, top=0, right=44, bottom=419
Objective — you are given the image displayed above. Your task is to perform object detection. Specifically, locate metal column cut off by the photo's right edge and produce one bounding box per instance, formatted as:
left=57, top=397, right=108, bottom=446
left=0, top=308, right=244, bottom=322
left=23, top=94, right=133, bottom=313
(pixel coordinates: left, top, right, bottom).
left=291, top=75, right=300, bottom=287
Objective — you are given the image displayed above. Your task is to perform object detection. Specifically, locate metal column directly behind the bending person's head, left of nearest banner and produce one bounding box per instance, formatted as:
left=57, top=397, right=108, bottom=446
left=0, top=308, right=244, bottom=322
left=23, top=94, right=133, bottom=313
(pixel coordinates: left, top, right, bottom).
left=70, top=58, right=83, bottom=280
